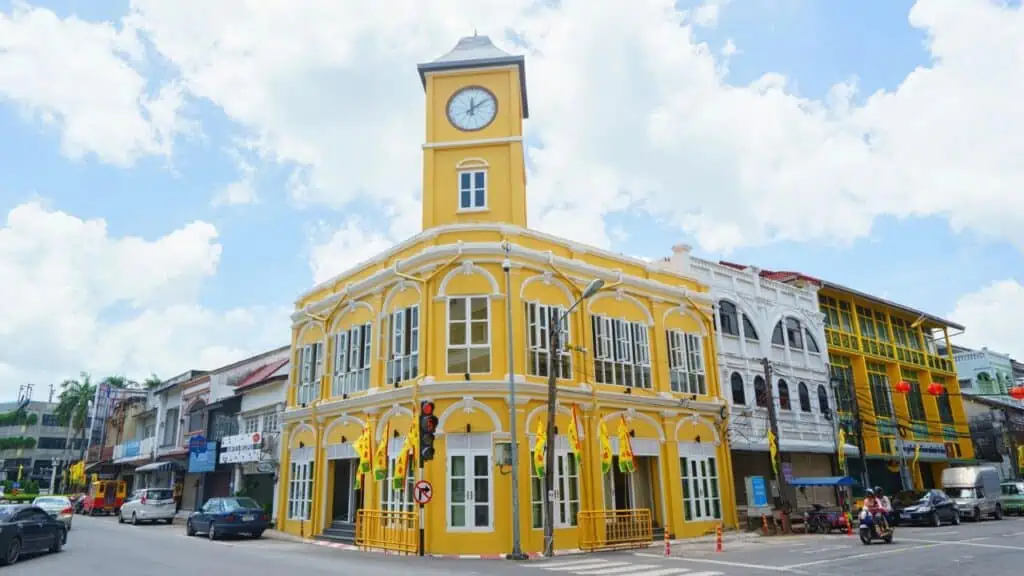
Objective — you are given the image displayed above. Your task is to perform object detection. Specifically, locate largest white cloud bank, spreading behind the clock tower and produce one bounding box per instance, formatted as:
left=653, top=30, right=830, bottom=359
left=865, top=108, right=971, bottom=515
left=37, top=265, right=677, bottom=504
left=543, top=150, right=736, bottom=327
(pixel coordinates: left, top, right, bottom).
left=116, top=0, right=1024, bottom=262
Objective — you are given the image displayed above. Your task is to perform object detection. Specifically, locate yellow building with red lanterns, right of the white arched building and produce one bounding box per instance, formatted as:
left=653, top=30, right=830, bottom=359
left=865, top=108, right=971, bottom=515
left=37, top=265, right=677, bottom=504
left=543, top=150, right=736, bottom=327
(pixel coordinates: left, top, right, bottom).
left=797, top=280, right=974, bottom=493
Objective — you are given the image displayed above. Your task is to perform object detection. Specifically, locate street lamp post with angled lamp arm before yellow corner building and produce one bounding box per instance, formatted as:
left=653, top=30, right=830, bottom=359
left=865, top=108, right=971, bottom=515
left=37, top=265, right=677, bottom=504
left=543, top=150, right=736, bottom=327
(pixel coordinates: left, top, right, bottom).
left=544, top=278, right=604, bottom=558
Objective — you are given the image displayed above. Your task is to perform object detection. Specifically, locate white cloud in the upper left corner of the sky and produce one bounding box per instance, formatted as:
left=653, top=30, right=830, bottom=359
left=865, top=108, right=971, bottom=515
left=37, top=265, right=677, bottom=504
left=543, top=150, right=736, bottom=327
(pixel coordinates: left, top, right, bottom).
left=0, top=0, right=188, bottom=166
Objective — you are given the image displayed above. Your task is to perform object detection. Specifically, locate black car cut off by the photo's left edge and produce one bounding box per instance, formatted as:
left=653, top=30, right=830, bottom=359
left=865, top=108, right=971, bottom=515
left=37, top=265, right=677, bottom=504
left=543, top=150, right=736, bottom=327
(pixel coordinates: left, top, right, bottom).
left=0, top=504, right=68, bottom=565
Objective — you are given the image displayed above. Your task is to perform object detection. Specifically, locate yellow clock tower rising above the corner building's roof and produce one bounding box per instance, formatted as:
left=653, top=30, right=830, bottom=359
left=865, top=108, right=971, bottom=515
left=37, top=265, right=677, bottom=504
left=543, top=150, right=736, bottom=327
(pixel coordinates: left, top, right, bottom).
left=419, top=35, right=529, bottom=230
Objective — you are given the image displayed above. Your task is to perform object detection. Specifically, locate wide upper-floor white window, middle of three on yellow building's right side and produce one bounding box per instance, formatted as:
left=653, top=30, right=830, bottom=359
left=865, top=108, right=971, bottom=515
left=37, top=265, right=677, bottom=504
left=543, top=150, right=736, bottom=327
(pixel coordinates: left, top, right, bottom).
left=591, top=315, right=653, bottom=388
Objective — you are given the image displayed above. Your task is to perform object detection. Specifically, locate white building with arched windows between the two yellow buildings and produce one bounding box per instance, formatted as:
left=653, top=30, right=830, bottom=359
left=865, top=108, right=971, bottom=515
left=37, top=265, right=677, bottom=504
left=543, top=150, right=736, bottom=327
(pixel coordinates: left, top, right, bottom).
left=666, top=246, right=856, bottom=516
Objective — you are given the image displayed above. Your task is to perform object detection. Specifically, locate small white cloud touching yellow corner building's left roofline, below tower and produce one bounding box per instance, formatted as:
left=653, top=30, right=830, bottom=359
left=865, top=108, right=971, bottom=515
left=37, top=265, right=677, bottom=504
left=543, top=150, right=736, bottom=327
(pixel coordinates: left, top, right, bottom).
left=309, top=217, right=394, bottom=284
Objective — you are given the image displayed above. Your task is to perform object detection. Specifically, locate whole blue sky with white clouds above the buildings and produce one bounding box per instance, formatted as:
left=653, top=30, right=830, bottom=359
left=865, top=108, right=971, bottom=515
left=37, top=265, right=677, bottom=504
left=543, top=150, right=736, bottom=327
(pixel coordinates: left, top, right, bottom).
left=0, top=0, right=1024, bottom=399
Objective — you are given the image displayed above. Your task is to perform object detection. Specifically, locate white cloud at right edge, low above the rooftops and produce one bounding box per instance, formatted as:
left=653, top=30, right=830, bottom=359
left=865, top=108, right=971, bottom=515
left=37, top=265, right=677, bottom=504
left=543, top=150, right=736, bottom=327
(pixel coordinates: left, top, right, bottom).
left=949, top=280, right=1024, bottom=360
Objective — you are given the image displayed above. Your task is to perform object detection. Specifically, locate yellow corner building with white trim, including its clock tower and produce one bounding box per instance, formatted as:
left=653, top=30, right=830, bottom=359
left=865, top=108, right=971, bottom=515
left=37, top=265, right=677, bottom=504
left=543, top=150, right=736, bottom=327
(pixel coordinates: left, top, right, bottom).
left=278, top=36, right=736, bottom=554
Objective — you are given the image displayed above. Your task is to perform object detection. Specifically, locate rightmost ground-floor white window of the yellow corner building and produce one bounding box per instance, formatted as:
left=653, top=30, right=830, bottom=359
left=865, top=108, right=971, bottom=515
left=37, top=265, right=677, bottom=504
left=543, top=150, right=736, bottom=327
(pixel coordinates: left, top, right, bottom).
left=679, top=443, right=723, bottom=522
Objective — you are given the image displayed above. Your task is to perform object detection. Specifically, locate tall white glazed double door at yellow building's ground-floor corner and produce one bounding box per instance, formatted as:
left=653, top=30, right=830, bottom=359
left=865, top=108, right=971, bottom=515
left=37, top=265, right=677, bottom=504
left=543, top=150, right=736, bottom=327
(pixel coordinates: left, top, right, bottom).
left=444, top=434, right=495, bottom=532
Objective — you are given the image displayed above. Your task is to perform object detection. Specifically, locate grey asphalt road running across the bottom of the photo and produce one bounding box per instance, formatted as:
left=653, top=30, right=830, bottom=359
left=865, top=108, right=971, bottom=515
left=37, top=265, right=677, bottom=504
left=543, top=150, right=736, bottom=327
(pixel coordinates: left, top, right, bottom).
left=9, top=517, right=1024, bottom=576
